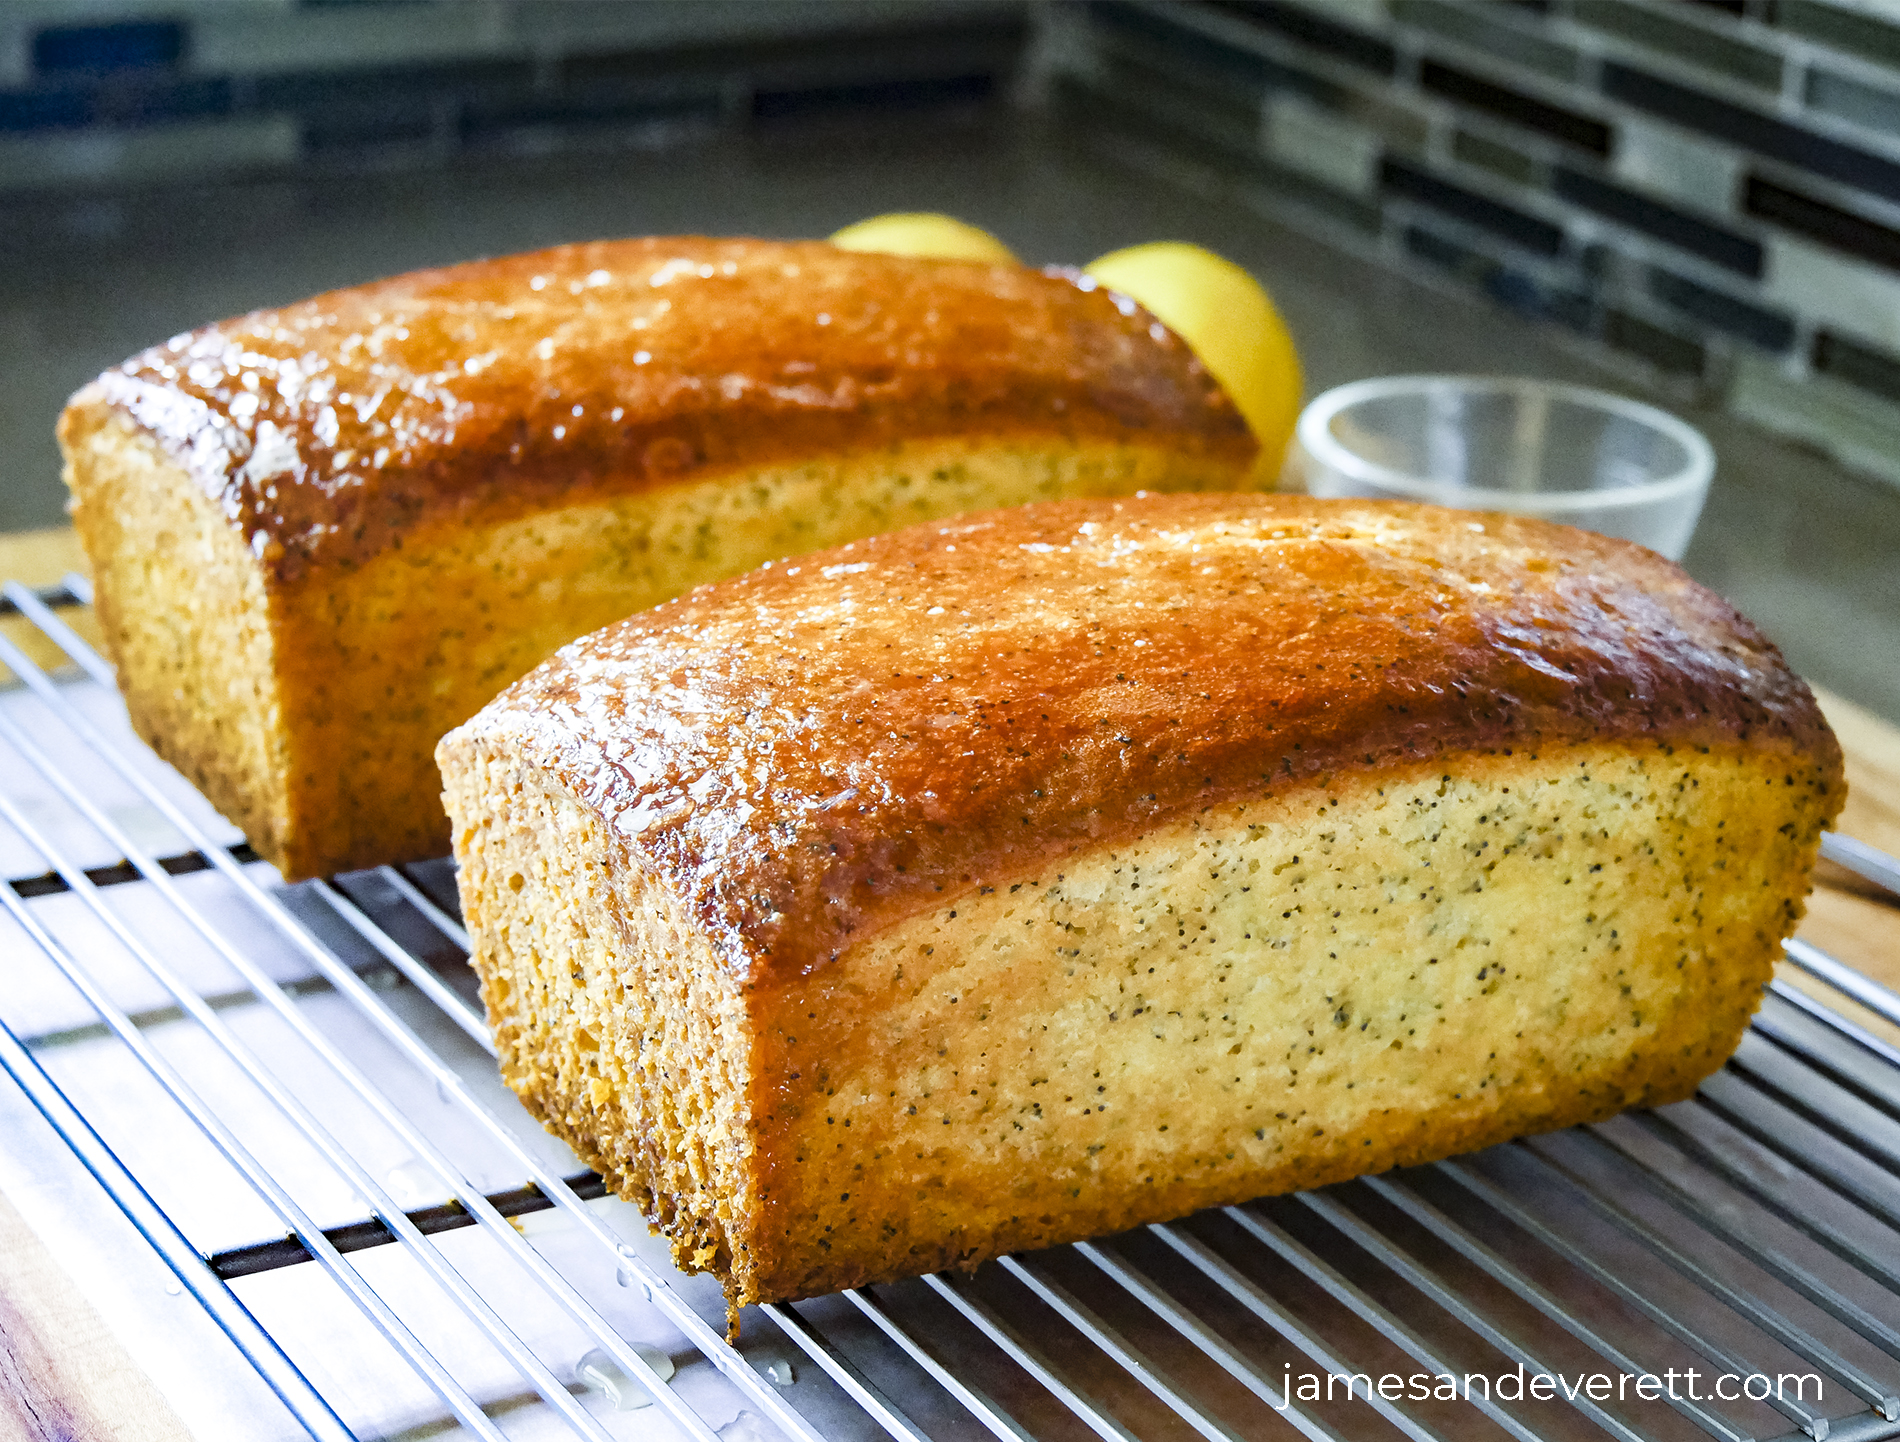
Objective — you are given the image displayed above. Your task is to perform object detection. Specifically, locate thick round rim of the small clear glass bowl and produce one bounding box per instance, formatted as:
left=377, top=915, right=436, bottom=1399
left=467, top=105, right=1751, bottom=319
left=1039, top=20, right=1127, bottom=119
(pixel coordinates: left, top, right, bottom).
left=1294, top=374, right=1716, bottom=515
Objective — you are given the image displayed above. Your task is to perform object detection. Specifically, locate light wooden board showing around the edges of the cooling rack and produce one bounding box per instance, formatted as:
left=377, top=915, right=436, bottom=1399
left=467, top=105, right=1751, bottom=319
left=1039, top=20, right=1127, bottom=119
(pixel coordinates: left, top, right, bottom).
left=0, top=526, right=1900, bottom=1442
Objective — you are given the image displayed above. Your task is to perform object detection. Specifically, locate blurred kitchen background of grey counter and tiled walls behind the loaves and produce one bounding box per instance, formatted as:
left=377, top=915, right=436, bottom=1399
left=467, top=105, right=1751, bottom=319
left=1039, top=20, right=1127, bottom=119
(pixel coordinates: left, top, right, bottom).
left=0, top=0, right=1900, bottom=718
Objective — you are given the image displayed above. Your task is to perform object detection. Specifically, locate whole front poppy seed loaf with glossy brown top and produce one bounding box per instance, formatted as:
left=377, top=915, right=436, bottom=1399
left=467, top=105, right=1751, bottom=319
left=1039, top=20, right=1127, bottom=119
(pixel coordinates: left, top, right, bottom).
left=439, top=496, right=1843, bottom=1305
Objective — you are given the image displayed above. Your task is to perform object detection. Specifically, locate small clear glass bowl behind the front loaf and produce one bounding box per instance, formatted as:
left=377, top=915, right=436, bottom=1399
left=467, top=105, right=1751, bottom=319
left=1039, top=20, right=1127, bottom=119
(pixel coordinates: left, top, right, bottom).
left=1286, top=376, right=1716, bottom=560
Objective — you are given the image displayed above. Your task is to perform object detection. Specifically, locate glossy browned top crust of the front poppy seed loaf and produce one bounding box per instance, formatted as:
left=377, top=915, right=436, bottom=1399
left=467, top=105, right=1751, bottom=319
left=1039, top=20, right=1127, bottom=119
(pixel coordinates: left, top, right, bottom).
left=469, top=496, right=1839, bottom=984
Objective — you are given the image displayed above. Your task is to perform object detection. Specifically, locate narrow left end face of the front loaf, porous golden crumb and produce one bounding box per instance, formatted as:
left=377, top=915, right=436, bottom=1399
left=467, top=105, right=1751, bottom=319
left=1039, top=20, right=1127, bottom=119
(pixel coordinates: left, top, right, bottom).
left=445, top=745, right=756, bottom=1286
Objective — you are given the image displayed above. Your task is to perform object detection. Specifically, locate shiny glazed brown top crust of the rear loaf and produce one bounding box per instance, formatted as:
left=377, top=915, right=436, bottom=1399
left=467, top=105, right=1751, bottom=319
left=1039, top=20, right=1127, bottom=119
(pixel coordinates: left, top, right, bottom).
left=63, top=237, right=1254, bottom=578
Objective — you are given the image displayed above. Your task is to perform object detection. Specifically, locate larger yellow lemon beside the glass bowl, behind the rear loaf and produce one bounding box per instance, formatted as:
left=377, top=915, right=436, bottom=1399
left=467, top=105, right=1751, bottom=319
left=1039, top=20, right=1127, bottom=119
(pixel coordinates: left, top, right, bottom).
left=1089, top=241, right=1302, bottom=479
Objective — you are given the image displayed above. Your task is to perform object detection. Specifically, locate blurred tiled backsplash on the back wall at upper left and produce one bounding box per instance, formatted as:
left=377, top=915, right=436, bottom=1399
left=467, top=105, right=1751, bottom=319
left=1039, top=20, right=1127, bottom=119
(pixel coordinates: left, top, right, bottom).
left=0, top=0, right=1030, bottom=196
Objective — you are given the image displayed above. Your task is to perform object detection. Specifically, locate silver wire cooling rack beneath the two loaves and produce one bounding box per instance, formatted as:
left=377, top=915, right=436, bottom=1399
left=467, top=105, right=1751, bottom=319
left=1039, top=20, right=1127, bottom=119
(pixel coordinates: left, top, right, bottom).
left=0, top=576, right=1900, bottom=1442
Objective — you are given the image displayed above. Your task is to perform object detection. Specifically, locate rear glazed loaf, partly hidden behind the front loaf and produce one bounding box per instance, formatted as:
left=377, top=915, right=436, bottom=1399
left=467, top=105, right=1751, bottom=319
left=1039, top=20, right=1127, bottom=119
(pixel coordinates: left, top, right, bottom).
left=61, top=237, right=1254, bottom=878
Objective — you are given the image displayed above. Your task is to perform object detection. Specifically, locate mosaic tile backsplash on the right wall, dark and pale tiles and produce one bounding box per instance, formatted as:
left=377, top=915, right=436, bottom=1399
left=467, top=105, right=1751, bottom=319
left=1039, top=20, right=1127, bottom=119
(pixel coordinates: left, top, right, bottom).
left=1049, top=0, right=1900, bottom=484
